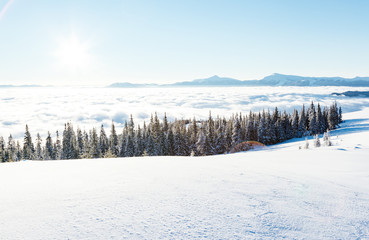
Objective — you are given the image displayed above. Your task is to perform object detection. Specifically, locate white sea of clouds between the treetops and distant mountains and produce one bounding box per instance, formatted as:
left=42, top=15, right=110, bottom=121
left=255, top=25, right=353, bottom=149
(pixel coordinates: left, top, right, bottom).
left=0, top=87, right=369, bottom=139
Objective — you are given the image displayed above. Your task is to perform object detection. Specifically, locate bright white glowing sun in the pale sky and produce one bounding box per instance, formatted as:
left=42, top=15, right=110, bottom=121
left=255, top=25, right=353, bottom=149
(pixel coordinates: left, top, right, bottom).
left=55, top=35, right=92, bottom=69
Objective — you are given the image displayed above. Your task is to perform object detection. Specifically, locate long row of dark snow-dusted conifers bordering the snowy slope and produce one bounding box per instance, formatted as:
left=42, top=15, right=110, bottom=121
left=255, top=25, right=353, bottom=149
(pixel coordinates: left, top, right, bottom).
left=0, top=102, right=342, bottom=162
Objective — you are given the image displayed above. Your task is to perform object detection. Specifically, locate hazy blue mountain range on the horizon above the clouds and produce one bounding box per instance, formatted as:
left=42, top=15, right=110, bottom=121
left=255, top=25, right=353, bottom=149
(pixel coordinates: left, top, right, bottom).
left=108, top=73, right=369, bottom=88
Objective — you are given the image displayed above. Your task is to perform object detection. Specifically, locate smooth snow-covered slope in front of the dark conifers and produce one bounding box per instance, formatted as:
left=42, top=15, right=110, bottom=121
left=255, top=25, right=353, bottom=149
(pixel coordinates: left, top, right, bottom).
left=0, top=108, right=369, bottom=239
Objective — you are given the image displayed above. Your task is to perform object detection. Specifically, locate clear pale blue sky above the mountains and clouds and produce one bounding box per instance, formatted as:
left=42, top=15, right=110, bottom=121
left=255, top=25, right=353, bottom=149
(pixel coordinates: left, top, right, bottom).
left=0, top=0, right=369, bottom=86
